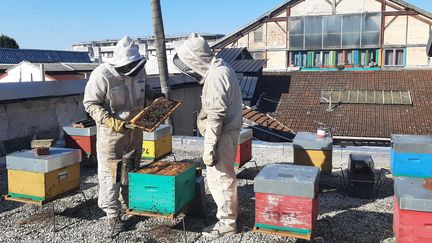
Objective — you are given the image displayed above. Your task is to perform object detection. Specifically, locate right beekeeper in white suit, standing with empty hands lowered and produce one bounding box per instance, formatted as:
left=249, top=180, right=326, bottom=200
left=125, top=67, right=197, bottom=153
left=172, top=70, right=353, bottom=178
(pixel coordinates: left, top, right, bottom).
left=173, top=34, right=243, bottom=237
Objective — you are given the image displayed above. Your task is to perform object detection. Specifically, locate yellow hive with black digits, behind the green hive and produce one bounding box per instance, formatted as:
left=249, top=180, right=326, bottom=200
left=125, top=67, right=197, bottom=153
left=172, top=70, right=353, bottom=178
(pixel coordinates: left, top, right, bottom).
left=142, top=125, right=172, bottom=160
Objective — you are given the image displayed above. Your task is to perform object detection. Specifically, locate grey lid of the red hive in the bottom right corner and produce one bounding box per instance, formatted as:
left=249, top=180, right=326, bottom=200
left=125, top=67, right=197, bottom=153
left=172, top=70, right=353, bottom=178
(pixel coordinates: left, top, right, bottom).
left=394, top=177, right=432, bottom=212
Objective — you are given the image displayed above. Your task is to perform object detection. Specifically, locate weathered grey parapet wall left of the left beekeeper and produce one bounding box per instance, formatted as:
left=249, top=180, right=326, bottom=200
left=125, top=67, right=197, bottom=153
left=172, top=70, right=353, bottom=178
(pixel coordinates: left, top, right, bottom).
left=0, top=96, right=87, bottom=154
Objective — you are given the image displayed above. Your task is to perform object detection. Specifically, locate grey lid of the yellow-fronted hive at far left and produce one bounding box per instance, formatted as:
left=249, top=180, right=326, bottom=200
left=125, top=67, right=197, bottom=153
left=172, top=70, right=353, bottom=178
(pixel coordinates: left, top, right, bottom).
left=6, top=147, right=81, bottom=173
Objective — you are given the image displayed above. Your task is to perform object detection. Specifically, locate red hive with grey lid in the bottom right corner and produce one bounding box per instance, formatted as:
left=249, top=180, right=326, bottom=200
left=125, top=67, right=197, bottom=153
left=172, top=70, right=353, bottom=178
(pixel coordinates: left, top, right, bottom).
left=393, top=177, right=432, bottom=243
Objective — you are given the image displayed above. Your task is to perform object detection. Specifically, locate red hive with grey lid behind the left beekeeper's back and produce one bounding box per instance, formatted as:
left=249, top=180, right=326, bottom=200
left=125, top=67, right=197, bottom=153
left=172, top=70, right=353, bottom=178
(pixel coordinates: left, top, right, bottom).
left=63, top=126, right=96, bottom=156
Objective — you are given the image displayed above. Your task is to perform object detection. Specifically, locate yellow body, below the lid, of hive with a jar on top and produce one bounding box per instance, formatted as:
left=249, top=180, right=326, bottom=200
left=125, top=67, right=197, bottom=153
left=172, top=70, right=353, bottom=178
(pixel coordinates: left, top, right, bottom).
left=294, top=149, right=333, bottom=174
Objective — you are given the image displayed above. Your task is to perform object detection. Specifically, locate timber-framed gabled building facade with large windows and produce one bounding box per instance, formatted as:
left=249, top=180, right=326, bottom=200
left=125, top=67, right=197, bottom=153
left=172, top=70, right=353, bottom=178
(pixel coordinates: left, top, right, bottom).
left=212, top=0, right=432, bottom=70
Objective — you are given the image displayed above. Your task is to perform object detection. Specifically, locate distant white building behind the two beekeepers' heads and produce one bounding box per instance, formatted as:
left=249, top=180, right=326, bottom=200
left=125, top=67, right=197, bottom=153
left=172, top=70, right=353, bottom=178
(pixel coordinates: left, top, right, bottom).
left=72, top=33, right=224, bottom=62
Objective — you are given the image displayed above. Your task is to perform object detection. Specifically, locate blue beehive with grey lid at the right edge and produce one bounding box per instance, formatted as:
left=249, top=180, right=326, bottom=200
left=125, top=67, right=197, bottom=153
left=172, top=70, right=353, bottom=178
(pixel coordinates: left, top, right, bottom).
left=390, top=135, right=432, bottom=178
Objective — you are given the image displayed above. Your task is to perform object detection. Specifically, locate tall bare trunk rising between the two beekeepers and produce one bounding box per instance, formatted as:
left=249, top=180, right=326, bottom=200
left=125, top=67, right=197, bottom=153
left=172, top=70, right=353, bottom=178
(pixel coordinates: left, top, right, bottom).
left=151, top=0, right=171, bottom=124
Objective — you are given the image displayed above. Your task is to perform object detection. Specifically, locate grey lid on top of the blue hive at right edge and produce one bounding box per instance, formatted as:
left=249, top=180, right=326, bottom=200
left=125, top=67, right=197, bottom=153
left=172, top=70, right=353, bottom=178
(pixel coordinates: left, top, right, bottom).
left=392, top=134, right=432, bottom=154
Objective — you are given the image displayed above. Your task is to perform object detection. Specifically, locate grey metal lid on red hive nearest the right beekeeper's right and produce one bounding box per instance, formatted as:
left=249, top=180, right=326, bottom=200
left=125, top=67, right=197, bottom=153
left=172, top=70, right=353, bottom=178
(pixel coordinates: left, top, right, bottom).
left=254, top=164, right=319, bottom=198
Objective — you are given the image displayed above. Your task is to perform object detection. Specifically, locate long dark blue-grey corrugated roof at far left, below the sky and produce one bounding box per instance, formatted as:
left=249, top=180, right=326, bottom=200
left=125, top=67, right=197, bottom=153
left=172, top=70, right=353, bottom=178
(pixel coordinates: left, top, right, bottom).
left=0, top=48, right=91, bottom=64
